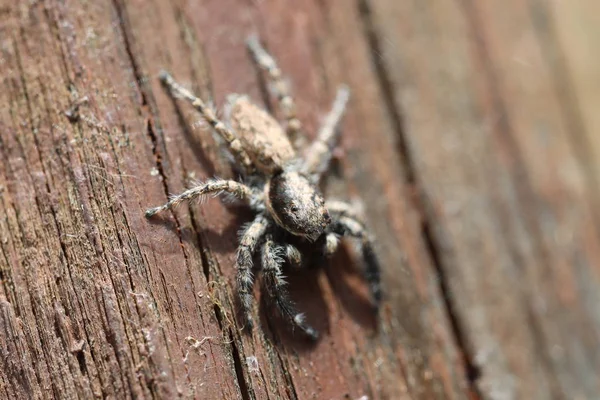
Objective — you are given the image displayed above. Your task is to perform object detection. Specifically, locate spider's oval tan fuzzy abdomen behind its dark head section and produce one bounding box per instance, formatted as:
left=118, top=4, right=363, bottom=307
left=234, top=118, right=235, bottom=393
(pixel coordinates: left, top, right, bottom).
left=227, top=95, right=296, bottom=175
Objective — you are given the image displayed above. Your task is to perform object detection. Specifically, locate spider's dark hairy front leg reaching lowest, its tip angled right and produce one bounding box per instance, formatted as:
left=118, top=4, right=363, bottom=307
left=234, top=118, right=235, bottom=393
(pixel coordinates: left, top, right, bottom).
left=262, top=237, right=319, bottom=340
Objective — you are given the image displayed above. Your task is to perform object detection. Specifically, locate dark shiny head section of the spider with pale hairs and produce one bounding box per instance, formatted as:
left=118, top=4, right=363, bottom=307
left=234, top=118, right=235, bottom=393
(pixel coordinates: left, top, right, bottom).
left=266, top=172, right=331, bottom=241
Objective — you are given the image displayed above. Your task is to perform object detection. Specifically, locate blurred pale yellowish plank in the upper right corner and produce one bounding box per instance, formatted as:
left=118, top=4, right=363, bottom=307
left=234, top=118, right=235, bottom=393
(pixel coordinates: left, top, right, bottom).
left=542, top=0, right=600, bottom=218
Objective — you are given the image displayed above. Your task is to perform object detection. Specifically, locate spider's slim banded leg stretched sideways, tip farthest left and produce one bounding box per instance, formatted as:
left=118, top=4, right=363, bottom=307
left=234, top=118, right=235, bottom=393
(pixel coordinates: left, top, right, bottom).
left=146, top=179, right=257, bottom=218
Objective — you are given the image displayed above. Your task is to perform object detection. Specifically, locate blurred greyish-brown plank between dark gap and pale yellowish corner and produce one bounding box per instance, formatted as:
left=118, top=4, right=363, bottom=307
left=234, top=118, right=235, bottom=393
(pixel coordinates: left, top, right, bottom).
left=369, top=1, right=600, bottom=398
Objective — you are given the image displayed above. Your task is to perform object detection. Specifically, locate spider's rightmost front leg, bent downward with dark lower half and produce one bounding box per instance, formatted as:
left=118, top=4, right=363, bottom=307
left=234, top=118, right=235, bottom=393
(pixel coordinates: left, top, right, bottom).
left=325, top=217, right=381, bottom=306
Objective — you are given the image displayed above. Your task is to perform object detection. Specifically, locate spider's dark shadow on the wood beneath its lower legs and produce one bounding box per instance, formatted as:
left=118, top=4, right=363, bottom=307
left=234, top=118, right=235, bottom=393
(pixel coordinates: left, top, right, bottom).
left=148, top=200, right=378, bottom=346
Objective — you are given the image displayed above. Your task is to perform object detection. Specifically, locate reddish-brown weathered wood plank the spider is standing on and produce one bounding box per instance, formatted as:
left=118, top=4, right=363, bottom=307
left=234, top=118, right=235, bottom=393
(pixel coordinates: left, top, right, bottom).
left=0, top=0, right=469, bottom=399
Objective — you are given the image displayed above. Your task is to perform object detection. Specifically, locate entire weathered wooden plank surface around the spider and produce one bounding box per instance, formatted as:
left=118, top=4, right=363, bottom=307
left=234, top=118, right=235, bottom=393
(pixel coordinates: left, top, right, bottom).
left=0, top=0, right=600, bottom=400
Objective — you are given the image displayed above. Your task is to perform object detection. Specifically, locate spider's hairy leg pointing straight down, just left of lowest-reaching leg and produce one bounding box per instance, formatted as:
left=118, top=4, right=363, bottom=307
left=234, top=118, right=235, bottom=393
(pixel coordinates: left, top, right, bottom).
left=236, top=215, right=269, bottom=329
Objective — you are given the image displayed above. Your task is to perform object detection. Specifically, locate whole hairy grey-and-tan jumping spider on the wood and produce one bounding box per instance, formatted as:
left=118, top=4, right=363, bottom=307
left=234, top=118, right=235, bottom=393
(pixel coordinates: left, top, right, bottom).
left=146, top=36, right=381, bottom=340
